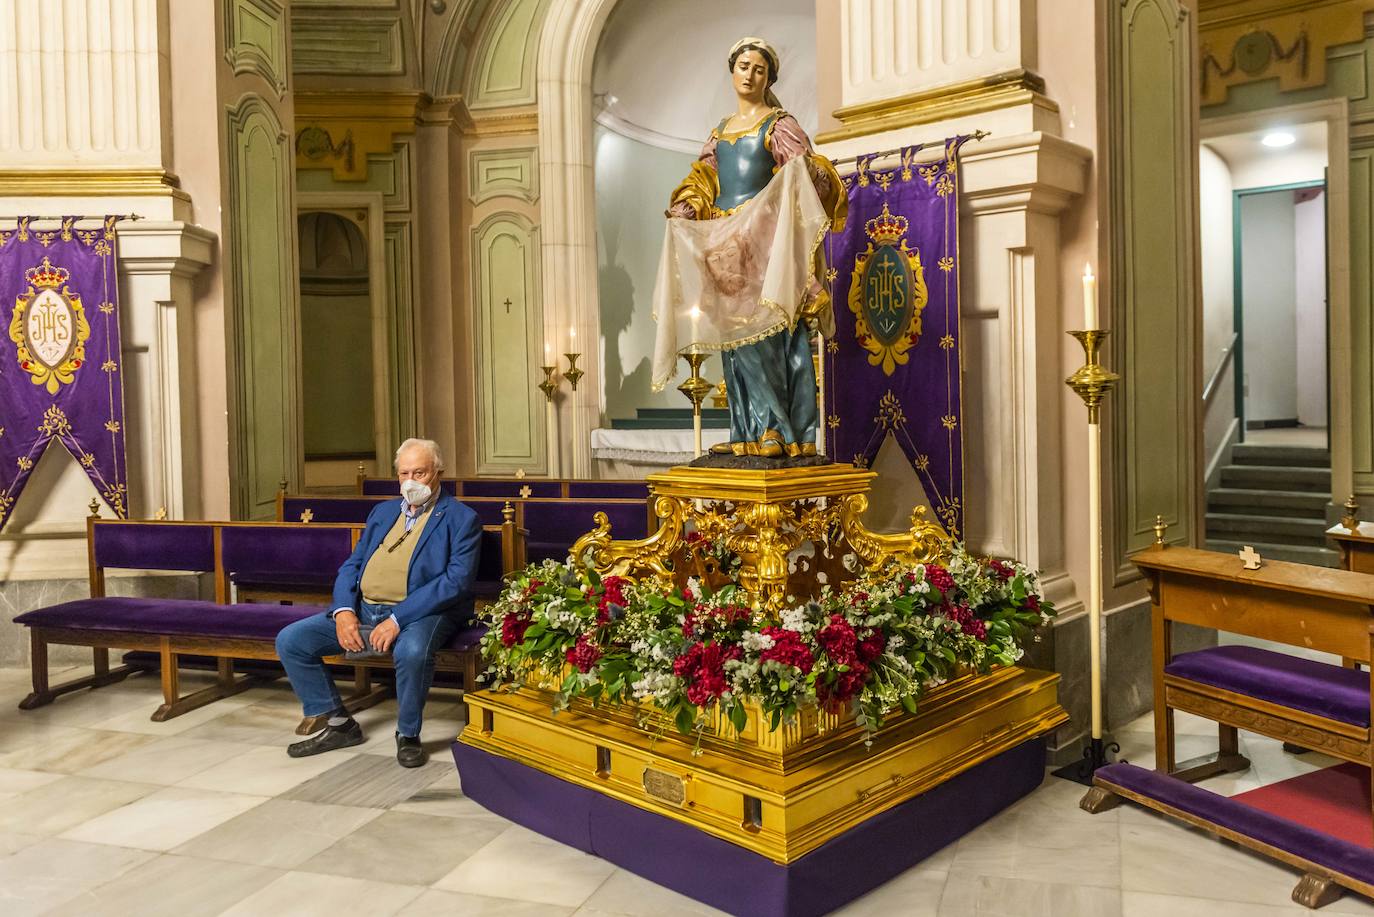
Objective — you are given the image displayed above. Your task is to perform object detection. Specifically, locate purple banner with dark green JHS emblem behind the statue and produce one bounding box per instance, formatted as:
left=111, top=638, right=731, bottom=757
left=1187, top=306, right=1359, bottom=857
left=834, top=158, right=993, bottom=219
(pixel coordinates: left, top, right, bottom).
left=824, top=137, right=966, bottom=538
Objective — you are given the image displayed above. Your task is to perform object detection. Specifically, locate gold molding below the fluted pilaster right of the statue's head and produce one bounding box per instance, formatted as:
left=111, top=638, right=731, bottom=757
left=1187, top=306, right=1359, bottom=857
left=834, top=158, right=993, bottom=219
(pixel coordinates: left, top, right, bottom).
left=816, top=70, right=1059, bottom=143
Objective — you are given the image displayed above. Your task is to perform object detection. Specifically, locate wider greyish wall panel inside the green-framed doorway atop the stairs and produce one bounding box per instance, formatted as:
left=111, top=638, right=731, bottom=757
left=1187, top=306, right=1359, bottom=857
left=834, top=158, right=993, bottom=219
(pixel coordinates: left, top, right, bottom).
left=1241, top=191, right=1297, bottom=421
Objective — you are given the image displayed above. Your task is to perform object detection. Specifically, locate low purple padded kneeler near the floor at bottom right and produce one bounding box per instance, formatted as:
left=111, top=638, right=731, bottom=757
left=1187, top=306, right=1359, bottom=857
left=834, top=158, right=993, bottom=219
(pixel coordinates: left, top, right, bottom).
left=1095, top=763, right=1374, bottom=883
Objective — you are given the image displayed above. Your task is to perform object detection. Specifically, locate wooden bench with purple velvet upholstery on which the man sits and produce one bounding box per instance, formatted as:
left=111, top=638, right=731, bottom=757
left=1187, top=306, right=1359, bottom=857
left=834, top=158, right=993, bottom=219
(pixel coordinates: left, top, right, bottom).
left=15, top=517, right=523, bottom=731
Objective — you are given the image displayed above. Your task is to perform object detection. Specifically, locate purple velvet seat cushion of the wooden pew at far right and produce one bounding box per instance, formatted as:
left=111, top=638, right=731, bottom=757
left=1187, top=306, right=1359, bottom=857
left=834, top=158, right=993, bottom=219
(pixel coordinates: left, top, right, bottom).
left=1164, top=646, right=1370, bottom=726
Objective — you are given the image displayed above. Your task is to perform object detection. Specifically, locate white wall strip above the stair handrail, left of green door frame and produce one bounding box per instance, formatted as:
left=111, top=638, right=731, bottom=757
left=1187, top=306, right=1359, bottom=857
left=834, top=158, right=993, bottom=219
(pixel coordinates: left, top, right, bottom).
left=1198, top=146, right=1235, bottom=466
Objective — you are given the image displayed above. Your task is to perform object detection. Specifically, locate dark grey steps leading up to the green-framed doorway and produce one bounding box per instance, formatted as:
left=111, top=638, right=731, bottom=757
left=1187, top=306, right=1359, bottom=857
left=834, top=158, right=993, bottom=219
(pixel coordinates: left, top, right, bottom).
left=1206, top=443, right=1340, bottom=566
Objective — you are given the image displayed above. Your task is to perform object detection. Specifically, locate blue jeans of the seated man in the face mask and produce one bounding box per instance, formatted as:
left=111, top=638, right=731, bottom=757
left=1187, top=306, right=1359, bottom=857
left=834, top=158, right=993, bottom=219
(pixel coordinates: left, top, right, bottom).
left=276, top=602, right=458, bottom=736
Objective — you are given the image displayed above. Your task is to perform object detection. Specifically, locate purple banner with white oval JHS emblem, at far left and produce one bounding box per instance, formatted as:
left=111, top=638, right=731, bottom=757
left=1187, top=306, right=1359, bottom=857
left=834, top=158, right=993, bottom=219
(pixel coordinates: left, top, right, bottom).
left=0, top=216, right=129, bottom=528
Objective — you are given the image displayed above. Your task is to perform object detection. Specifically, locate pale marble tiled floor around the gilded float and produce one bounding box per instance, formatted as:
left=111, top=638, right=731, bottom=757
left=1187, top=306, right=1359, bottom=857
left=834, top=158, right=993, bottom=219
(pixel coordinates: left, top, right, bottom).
left=0, top=668, right=1374, bottom=917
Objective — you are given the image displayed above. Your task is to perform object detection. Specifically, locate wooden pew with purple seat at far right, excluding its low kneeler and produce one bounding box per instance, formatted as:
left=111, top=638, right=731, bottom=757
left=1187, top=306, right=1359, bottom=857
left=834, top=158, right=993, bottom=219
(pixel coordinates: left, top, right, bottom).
left=1131, top=547, right=1374, bottom=781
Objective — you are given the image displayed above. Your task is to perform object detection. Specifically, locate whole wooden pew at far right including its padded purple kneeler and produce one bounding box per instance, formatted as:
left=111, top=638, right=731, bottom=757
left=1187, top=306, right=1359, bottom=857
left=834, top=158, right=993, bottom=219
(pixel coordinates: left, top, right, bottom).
left=1080, top=546, right=1374, bottom=907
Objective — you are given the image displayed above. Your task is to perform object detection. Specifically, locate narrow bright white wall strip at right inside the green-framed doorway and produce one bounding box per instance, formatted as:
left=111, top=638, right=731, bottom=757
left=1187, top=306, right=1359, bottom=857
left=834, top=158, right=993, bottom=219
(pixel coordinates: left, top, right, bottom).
left=1293, top=192, right=1326, bottom=426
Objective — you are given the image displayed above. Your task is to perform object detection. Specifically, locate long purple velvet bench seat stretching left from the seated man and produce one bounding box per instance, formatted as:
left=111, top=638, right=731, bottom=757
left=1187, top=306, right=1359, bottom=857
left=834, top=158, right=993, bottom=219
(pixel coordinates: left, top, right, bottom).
left=14, top=597, right=324, bottom=641
